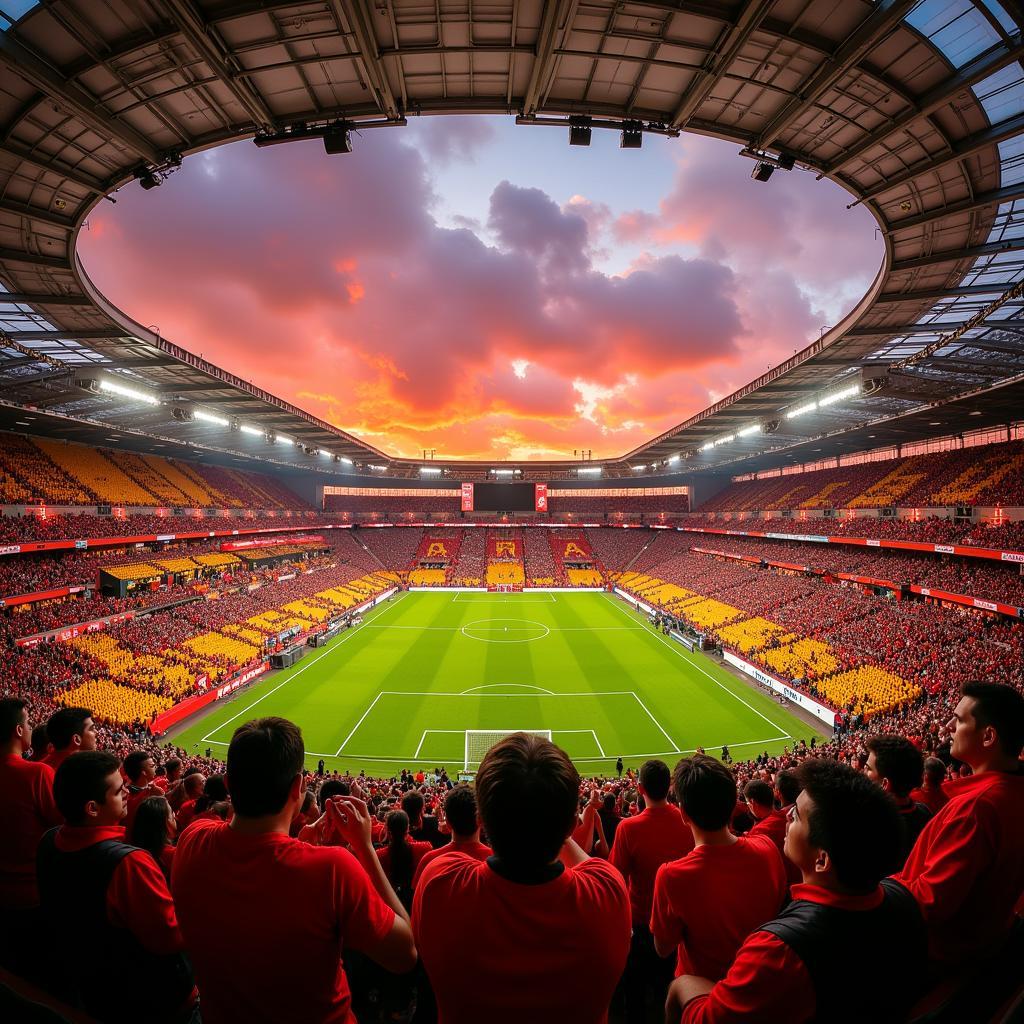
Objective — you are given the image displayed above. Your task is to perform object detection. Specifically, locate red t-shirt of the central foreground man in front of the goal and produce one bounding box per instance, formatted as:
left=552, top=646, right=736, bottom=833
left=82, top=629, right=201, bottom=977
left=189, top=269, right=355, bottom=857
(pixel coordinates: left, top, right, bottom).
left=413, top=853, right=631, bottom=1024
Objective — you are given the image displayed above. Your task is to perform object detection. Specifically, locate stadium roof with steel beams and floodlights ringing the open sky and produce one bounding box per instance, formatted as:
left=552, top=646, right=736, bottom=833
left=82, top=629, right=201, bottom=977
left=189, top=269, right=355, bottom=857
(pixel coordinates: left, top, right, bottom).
left=0, top=0, right=1024, bottom=476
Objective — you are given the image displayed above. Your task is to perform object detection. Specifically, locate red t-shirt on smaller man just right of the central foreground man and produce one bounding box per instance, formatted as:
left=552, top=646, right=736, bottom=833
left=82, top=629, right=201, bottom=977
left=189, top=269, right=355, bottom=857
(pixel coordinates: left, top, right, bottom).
left=611, top=804, right=693, bottom=926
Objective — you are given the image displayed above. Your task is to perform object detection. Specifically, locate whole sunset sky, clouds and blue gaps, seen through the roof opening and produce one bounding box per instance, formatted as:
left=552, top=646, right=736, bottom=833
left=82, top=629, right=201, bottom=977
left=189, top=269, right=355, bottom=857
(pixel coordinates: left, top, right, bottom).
left=79, top=118, right=882, bottom=460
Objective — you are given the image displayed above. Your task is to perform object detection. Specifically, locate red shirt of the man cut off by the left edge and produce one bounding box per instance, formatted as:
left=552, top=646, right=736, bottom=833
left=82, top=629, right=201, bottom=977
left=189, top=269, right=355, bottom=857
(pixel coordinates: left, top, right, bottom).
left=0, top=755, right=62, bottom=908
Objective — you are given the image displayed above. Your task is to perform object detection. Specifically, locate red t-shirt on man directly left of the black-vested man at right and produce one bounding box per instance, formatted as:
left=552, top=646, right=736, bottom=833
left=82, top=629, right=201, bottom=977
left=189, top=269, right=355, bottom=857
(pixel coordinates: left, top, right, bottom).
left=650, top=836, right=788, bottom=981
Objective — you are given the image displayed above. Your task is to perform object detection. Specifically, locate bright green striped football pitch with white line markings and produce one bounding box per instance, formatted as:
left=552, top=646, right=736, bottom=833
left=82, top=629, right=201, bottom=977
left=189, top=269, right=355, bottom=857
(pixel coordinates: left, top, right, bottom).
left=173, top=592, right=822, bottom=775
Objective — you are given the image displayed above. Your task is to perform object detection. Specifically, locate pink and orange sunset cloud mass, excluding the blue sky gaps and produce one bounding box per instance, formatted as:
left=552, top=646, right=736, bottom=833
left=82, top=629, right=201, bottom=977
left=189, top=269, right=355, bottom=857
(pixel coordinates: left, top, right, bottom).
left=80, top=130, right=876, bottom=458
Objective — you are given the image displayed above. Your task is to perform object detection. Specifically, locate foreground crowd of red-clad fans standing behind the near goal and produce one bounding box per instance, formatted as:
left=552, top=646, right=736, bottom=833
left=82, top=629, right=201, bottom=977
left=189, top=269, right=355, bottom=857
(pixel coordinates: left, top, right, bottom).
left=0, top=682, right=1024, bottom=1024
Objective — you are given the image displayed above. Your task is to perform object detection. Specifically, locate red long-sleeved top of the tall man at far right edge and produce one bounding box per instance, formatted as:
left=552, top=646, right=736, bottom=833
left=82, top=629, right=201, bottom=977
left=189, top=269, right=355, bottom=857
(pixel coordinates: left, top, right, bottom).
left=895, top=769, right=1024, bottom=965
